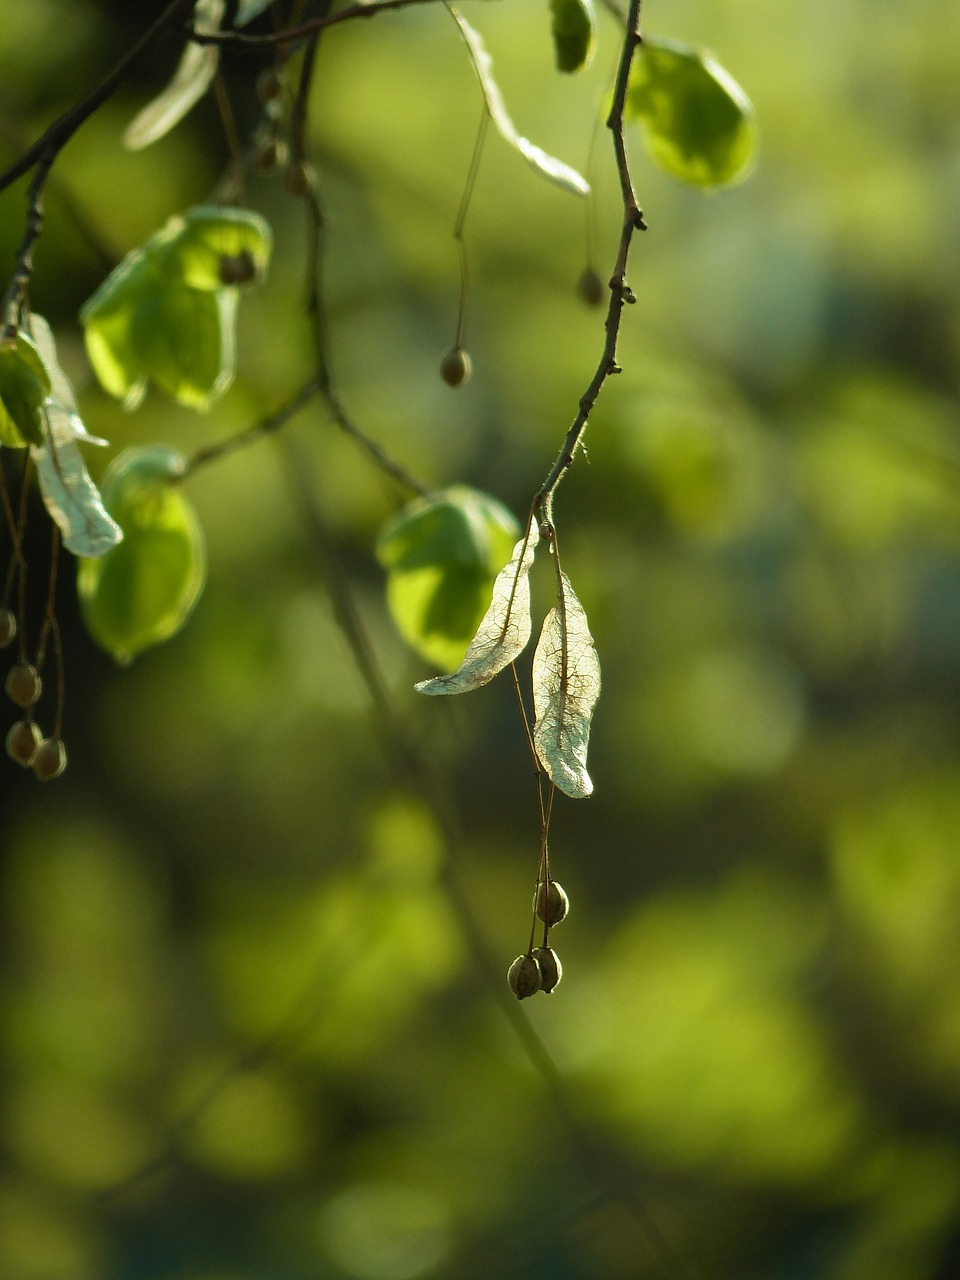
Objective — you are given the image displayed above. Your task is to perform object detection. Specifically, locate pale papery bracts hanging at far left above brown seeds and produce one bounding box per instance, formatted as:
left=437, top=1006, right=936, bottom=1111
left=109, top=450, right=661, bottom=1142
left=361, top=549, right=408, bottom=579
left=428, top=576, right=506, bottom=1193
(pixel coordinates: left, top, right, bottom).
left=31, top=314, right=123, bottom=558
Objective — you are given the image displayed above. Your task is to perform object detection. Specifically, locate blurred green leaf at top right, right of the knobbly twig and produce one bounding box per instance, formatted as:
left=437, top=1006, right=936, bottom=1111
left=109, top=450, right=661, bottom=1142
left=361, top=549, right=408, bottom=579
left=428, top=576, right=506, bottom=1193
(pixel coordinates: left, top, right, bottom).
left=625, top=37, right=758, bottom=187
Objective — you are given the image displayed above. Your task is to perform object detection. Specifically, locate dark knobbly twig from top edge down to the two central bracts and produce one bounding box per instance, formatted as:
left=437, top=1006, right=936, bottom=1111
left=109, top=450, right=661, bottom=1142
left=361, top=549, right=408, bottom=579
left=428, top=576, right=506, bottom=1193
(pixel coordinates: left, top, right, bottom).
left=534, top=0, right=646, bottom=526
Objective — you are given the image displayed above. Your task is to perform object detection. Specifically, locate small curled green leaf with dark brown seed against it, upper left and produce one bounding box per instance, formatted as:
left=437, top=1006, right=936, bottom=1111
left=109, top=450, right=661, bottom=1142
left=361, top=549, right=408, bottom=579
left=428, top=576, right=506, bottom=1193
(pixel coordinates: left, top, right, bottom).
left=161, top=205, right=273, bottom=291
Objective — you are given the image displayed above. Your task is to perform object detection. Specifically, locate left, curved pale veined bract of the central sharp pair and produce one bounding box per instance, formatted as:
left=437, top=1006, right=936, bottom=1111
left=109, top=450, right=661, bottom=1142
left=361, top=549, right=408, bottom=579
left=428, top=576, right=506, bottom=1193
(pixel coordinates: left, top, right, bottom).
left=416, top=520, right=540, bottom=694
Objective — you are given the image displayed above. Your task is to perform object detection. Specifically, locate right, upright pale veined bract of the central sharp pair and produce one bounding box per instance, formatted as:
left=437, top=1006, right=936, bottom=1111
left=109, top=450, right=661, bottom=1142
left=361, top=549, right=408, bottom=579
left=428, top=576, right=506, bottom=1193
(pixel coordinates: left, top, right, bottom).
left=532, top=572, right=600, bottom=799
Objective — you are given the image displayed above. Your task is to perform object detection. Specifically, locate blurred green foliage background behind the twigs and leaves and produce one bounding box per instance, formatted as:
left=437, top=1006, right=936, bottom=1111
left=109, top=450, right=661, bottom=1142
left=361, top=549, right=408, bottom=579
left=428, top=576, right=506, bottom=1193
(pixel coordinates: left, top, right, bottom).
left=0, top=0, right=960, bottom=1280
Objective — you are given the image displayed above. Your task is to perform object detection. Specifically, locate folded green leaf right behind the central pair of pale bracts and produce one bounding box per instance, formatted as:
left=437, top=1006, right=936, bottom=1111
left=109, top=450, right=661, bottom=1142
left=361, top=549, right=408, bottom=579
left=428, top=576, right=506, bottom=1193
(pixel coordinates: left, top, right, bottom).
left=376, top=485, right=518, bottom=671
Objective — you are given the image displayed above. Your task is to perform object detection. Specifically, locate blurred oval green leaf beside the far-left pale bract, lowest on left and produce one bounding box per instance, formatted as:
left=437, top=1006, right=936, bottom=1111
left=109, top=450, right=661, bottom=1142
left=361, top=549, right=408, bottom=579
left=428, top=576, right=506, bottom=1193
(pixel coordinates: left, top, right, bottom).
left=77, top=447, right=206, bottom=663
